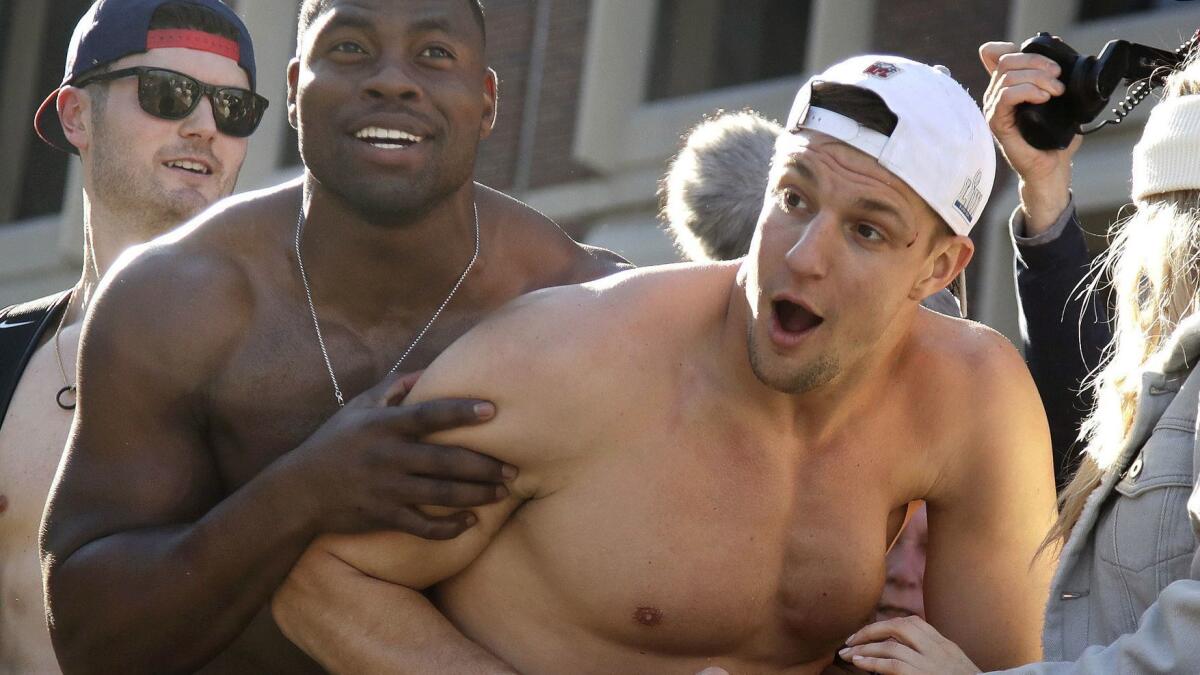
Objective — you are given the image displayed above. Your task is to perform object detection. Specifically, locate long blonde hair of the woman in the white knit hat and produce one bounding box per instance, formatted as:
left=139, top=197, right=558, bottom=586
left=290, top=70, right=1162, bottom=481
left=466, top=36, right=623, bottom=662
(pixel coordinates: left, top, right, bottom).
left=1043, top=60, right=1200, bottom=550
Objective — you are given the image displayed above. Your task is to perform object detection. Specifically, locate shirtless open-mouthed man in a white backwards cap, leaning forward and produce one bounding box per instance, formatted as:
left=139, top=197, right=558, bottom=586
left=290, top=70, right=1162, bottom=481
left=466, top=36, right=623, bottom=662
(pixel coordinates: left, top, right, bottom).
left=274, top=56, right=1054, bottom=674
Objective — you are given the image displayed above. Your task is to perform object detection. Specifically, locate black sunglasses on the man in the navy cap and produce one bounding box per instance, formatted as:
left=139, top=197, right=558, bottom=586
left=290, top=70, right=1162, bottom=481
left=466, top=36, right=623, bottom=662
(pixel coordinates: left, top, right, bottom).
left=74, top=66, right=269, bottom=138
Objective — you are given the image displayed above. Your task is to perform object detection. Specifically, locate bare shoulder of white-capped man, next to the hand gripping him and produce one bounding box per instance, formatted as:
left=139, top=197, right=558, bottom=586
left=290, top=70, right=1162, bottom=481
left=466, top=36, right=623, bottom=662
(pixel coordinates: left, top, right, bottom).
left=410, top=260, right=736, bottom=466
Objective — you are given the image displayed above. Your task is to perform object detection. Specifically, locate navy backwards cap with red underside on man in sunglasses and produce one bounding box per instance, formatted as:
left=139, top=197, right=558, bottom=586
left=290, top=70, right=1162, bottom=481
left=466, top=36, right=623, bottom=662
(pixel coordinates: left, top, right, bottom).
left=34, top=0, right=254, bottom=153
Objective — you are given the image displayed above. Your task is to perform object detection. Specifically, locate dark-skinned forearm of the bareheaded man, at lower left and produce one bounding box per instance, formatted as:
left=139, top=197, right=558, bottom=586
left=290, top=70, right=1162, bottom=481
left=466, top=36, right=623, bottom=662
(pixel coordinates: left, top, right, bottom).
left=46, top=468, right=312, bottom=673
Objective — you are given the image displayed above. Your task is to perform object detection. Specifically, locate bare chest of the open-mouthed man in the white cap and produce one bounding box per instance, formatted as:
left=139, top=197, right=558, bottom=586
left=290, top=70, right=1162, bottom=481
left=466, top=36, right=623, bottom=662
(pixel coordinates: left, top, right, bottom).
left=446, top=413, right=921, bottom=662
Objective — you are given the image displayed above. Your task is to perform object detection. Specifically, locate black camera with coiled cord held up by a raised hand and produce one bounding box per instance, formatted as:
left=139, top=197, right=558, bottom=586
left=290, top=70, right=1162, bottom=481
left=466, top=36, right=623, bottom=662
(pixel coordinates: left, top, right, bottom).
left=1015, top=31, right=1200, bottom=150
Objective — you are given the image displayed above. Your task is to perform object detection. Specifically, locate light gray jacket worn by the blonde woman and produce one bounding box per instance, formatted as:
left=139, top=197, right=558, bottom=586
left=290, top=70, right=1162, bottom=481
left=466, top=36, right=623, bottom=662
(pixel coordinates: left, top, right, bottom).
left=1006, top=316, right=1200, bottom=675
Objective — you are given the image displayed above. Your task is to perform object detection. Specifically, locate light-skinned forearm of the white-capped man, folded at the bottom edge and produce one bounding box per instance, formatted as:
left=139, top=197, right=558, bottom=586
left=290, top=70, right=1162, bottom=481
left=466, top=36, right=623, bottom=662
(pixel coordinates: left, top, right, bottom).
left=272, top=549, right=515, bottom=675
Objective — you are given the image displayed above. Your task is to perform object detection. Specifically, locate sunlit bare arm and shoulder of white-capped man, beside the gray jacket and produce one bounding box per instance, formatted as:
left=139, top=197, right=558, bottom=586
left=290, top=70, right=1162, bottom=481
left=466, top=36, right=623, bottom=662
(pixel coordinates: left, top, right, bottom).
left=917, top=317, right=1055, bottom=671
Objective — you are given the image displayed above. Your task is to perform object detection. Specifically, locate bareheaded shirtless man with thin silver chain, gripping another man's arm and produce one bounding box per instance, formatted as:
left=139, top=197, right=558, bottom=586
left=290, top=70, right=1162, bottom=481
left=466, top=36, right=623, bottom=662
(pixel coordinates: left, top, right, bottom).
left=36, top=0, right=619, bottom=673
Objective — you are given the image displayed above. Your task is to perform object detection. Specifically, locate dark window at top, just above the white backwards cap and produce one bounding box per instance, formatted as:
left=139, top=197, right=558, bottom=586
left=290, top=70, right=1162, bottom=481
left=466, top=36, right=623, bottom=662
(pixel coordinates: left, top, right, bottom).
left=646, top=0, right=811, bottom=101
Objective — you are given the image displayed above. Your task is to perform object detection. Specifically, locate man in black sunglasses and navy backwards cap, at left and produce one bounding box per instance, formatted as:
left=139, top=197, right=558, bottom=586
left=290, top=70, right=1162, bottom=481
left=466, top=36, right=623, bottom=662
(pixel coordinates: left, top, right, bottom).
left=0, top=0, right=266, bottom=673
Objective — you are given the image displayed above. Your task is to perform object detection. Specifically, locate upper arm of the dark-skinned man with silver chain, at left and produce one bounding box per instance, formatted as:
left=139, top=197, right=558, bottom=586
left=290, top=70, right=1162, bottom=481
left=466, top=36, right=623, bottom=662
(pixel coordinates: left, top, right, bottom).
left=44, top=254, right=238, bottom=556
